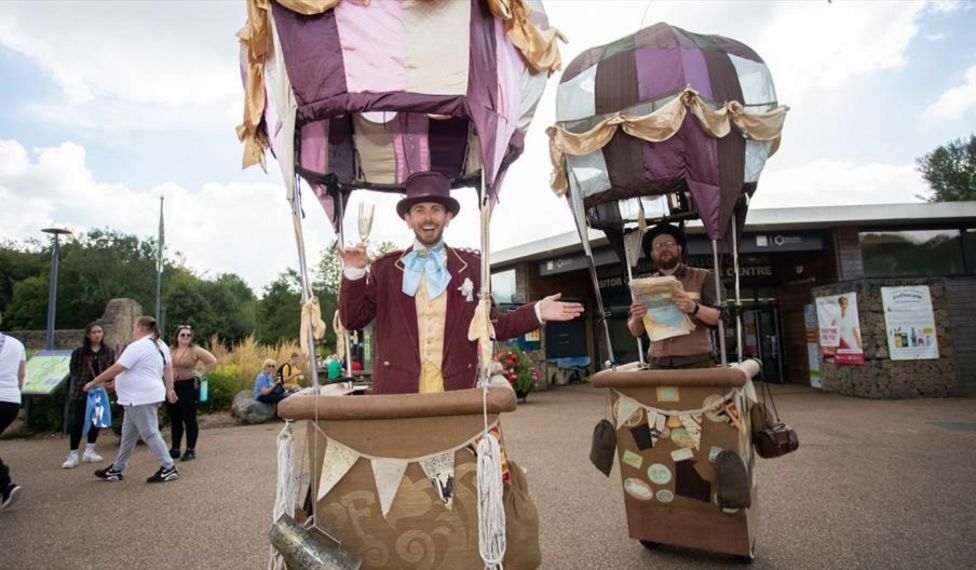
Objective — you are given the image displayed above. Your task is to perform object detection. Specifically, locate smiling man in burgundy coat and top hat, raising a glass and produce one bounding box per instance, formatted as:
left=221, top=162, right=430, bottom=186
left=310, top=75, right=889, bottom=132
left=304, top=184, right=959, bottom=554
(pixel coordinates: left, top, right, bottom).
left=339, top=172, right=583, bottom=394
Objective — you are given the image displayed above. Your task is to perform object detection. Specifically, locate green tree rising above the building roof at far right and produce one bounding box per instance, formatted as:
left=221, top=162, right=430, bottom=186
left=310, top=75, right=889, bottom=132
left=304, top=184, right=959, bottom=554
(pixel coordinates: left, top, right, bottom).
left=915, top=134, right=976, bottom=202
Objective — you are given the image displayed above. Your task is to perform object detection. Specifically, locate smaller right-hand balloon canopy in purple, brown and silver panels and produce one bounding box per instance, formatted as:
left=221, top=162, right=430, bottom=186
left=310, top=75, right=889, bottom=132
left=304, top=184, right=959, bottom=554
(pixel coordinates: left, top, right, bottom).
left=549, top=23, right=787, bottom=238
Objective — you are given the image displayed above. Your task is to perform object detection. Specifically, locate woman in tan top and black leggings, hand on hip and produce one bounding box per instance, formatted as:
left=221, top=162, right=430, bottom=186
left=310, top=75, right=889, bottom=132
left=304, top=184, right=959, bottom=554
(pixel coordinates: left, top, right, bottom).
left=166, top=325, right=217, bottom=461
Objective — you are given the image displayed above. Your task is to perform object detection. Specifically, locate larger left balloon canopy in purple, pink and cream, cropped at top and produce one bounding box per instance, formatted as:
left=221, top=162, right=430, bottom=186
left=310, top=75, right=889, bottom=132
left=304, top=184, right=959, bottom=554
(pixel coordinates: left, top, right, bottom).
left=238, top=0, right=561, bottom=226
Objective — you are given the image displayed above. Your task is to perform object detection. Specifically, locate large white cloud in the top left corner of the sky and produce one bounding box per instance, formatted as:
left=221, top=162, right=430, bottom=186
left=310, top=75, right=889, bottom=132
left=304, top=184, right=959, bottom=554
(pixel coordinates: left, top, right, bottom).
left=0, top=2, right=245, bottom=130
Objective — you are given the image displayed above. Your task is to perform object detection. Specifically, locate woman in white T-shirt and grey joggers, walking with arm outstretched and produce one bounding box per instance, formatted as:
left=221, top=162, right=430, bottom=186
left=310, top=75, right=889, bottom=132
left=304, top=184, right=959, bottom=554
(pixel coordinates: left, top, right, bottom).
left=85, top=317, right=180, bottom=483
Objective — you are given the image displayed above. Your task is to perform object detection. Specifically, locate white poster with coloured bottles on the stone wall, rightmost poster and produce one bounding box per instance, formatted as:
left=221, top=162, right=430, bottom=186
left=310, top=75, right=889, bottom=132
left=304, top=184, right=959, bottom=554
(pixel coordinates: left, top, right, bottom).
left=881, top=285, right=939, bottom=360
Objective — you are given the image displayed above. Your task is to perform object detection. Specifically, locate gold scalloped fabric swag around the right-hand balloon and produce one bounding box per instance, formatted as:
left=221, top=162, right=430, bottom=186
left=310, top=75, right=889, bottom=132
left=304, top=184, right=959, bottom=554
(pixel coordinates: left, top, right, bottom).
left=546, top=87, right=789, bottom=196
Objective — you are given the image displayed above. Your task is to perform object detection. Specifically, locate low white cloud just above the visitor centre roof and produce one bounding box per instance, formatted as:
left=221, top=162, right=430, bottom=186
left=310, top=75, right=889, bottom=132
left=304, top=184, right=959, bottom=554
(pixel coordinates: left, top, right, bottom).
left=751, top=159, right=929, bottom=208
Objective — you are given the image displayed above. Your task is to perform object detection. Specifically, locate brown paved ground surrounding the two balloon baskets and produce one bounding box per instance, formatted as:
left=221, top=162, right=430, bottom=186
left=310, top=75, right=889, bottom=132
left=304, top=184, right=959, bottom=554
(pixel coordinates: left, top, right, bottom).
left=0, top=386, right=976, bottom=570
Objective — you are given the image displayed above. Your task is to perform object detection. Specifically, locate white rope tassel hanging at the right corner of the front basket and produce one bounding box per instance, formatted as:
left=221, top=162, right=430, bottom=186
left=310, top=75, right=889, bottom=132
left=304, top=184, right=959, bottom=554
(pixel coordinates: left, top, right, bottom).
left=478, top=432, right=506, bottom=570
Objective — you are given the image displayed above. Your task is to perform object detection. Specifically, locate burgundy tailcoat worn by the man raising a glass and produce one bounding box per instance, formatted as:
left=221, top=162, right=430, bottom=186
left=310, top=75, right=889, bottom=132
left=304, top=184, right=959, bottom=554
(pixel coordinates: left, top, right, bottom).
left=339, top=247, right=540, bottom=394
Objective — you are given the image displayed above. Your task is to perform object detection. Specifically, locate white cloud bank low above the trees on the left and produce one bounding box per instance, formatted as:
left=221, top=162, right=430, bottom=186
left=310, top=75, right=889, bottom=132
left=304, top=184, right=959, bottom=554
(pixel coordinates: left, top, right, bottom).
left=0, top=140, right=344, bottom=289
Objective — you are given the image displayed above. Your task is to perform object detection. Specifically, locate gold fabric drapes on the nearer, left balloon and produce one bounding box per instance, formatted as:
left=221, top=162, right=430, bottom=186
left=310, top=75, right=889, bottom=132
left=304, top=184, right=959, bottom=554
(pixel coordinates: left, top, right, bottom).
left=237, top=0, right=566, bottom=170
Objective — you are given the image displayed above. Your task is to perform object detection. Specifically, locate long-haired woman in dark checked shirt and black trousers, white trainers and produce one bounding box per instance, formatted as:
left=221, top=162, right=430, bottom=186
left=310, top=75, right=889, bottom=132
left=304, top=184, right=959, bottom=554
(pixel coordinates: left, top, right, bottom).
left=61, top=323, right=115, bottom=469
